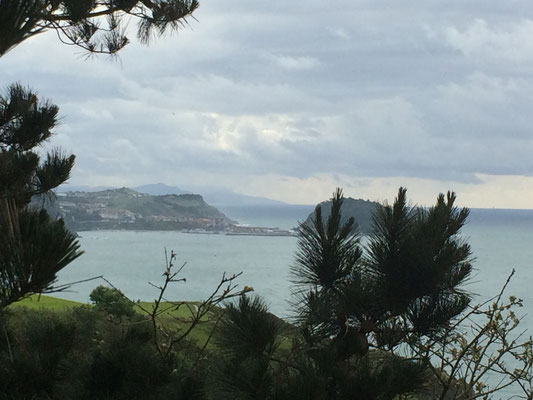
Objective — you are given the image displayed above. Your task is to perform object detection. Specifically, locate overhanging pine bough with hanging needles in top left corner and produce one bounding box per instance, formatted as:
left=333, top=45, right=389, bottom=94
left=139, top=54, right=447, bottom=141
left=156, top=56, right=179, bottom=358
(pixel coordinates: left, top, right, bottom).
left=0, top=0, right=199, bottom=57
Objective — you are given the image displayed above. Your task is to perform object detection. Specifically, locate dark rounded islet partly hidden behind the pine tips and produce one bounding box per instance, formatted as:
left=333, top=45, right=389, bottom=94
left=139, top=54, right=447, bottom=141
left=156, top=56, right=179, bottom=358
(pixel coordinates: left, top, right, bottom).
left=304, top=197, right=380, bottom=234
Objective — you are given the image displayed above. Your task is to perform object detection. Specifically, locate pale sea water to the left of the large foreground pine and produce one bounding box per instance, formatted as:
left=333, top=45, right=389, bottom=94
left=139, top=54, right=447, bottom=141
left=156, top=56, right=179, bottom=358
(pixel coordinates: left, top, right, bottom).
left=54, top=206, right=313, bottom=316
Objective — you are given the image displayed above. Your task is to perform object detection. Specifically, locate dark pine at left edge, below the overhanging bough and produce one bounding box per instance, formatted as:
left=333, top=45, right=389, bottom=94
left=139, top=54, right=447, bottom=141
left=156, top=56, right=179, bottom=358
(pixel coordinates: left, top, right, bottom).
left=0, top=84, right=81, bottom=309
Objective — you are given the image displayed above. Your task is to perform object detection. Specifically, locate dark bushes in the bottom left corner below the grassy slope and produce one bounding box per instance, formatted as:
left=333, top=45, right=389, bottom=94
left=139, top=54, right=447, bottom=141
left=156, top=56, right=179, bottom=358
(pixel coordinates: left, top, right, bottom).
left=0, top=307, right=200, bottom=400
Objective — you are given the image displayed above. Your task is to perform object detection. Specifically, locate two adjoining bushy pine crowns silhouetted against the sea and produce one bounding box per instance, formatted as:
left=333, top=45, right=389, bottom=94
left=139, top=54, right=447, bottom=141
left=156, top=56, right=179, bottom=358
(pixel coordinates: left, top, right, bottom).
left=293, top=188, right=471, bottom=358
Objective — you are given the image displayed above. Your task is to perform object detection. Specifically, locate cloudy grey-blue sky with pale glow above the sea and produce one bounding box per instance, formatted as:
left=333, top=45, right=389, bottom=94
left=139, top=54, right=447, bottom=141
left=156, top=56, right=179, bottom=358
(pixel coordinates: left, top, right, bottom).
left=0, top=0, right=533, bottom=209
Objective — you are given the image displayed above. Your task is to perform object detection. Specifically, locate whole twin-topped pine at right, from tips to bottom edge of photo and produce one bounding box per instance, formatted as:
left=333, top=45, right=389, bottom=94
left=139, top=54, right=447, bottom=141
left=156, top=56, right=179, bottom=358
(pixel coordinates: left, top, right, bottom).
left=293, top=188, right=472, bottom=399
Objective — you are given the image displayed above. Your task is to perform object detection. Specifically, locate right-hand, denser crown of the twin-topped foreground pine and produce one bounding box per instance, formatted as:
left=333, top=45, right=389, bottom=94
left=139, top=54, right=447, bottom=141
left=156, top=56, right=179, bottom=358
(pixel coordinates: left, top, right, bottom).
left=366, top=188, right=472, bottom=335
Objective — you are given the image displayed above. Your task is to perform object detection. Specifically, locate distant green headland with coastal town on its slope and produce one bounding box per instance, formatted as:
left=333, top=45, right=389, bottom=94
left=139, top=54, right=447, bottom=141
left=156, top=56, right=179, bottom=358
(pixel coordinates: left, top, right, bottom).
left=54, top=188, right=232, bottom=231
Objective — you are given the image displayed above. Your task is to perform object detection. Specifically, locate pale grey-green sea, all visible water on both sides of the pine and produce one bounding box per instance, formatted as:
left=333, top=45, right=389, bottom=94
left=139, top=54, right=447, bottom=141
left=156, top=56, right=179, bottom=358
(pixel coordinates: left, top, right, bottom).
left=51, top=206, right=533, bottom=398
